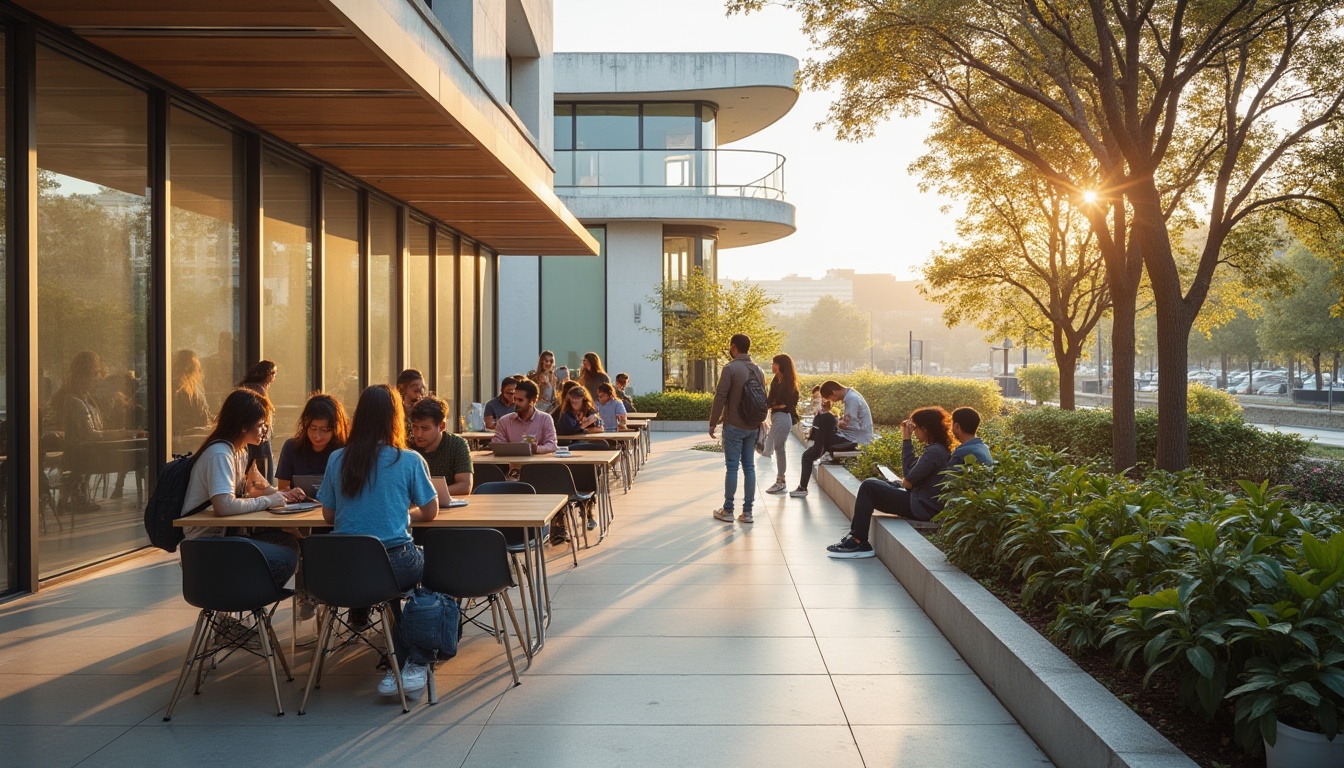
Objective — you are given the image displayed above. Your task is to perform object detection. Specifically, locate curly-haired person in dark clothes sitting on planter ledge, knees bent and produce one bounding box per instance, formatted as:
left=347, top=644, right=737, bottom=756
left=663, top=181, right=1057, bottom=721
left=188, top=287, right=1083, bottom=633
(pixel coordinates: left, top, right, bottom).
left=827, top=406, right=954, bottom=558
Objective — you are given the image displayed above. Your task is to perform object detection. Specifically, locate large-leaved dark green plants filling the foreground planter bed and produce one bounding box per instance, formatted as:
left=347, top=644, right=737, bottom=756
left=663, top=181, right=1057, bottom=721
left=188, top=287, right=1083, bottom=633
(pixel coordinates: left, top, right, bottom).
left=938, top=437, right=1344, bottom=749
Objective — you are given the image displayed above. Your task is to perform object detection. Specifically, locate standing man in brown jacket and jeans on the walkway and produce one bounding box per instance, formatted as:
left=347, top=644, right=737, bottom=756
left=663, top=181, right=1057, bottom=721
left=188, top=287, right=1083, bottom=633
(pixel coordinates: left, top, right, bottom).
left=710, top=334, right=770, bottom=523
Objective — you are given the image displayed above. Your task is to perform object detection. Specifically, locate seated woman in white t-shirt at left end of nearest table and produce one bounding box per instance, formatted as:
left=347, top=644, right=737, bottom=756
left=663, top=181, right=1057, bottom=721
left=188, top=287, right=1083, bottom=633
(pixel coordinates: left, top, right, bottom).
left=181, top=389, right=304, bottom=586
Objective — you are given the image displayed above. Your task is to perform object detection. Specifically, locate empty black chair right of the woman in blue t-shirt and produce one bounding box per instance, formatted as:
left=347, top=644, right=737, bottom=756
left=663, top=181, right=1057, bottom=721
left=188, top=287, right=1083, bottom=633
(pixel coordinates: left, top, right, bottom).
left=421, top=529, right=532, bottom=703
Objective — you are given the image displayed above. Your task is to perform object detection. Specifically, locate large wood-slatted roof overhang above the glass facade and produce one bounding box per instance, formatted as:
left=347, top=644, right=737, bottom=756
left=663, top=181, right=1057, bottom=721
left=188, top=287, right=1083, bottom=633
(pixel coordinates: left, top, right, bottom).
left=17, top=0, right=598, bottom=254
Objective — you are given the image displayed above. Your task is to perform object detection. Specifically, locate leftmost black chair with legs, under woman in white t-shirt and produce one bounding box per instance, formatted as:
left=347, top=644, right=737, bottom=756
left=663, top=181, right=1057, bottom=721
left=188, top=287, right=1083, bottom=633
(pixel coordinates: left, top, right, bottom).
left=164, top=537, right=294, bottom=721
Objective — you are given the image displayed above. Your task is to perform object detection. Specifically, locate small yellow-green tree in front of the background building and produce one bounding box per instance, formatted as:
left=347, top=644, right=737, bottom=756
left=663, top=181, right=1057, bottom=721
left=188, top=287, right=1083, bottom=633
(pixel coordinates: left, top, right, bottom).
left=642, top=269, right=784, bottom=387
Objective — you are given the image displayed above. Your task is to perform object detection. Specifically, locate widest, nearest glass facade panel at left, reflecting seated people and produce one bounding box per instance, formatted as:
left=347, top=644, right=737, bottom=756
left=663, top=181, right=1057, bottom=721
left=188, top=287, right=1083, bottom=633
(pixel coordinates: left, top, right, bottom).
left=36, top=47, right=152, bottom=578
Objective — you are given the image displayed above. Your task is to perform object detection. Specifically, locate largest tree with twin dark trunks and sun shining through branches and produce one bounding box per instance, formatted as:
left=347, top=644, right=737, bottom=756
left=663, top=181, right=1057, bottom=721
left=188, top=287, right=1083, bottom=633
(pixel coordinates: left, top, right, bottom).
left=728, top=0, right=1344, bottom=469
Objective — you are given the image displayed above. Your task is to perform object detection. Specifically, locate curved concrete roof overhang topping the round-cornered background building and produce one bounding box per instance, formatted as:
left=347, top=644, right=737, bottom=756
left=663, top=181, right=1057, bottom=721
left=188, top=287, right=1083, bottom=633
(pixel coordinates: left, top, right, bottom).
left=555, top=54, right=798, bottom=147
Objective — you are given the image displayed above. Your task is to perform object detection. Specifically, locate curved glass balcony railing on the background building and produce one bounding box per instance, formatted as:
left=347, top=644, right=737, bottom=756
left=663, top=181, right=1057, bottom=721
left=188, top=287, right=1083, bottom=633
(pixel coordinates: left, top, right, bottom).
left=555, top=149, right=784, bottom=200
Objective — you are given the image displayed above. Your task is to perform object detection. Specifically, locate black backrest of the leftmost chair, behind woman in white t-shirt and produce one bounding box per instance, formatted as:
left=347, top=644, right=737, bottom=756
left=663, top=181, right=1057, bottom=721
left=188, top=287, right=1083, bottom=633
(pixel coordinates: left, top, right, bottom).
left=177, top=537, right=288, bottom=612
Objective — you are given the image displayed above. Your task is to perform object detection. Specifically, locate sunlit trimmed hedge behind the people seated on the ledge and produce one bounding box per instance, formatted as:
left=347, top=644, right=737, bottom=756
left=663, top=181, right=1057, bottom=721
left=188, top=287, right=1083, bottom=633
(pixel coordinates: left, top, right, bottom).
left=798, top=369, right=1004, bottom=426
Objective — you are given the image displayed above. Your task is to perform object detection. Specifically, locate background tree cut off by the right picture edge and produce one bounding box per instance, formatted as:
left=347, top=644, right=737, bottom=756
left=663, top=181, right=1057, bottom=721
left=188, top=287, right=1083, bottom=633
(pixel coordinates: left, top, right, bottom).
left=1259, top=246, right=1344, bottom=389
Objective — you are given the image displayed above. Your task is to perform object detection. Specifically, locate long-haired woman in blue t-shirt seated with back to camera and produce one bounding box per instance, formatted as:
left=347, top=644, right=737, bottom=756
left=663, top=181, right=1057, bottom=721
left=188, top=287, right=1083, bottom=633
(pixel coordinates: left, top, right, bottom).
left=317, top=385, right=438, bottom=695
